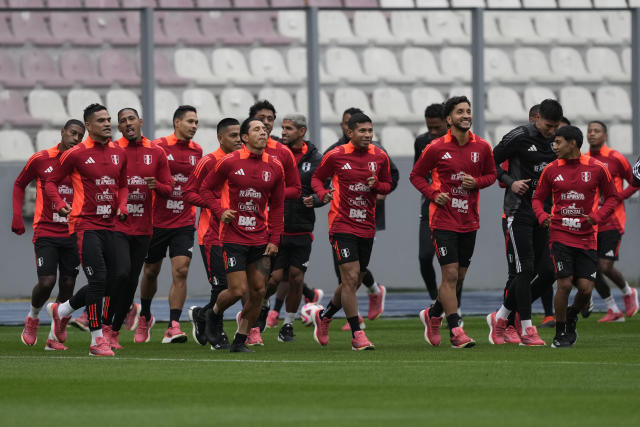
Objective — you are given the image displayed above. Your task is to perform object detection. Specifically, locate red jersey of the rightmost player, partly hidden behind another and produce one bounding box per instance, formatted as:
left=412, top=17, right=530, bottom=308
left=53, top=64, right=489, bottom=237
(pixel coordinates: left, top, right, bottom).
left=585, top=145, right=638, bottom=234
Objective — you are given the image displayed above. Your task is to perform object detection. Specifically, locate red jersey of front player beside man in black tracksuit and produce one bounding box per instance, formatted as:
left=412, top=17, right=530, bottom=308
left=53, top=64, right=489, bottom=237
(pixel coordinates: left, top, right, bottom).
left=532, top=155, right=620, bottom=249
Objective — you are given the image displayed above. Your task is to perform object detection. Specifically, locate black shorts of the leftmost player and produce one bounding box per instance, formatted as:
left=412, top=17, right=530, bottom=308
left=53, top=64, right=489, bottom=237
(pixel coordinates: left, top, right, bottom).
left=33, top=237, right=80, bottom=277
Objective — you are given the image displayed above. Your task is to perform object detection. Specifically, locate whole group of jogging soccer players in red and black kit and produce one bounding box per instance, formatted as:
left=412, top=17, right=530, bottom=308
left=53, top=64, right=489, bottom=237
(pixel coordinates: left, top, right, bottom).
left=11, top=96, right=640, bottom=356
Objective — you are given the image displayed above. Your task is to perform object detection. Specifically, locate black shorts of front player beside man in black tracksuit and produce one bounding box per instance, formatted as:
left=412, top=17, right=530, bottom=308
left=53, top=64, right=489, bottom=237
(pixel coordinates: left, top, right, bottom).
left=550, top=242, right=598, bottom=281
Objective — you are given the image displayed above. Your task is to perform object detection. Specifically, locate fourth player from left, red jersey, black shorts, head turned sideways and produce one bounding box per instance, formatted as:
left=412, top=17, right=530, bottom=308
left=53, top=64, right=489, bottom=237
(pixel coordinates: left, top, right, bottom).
left=134, top=105, right=202, bottom=344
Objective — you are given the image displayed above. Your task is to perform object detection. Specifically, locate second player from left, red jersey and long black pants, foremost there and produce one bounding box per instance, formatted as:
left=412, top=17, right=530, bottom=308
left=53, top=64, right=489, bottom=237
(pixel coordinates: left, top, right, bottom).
left=45, top=104, right=129, bottom=356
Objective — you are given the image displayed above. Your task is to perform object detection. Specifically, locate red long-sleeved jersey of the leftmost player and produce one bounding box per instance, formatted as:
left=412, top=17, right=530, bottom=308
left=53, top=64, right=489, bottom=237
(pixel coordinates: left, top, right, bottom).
left=13, top=145, right=73, bottom=242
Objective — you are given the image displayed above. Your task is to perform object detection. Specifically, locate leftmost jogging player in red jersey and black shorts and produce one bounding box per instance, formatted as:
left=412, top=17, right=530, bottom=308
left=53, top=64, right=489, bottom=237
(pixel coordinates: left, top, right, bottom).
left=11, top=119, right=85, bottom=350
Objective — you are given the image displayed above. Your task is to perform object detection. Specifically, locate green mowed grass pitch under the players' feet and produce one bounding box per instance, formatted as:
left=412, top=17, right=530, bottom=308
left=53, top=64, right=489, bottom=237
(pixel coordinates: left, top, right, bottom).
left=0, top=314, right=640, bottom=427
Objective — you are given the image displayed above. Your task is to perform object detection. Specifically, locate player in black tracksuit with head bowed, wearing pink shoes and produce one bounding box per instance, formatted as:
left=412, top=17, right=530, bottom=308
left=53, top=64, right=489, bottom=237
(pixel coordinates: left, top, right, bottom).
left=487, top=99, right=562, bottom=346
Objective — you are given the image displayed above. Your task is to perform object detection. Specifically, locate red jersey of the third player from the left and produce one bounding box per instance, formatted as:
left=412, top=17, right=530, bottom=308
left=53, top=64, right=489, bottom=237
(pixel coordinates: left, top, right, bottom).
left=116, top=136, right=173, bottom=236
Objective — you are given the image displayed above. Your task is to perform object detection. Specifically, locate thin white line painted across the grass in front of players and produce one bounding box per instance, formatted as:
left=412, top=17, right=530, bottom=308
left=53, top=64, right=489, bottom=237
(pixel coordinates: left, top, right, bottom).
left=0, top=355, right=640, bottom=368
